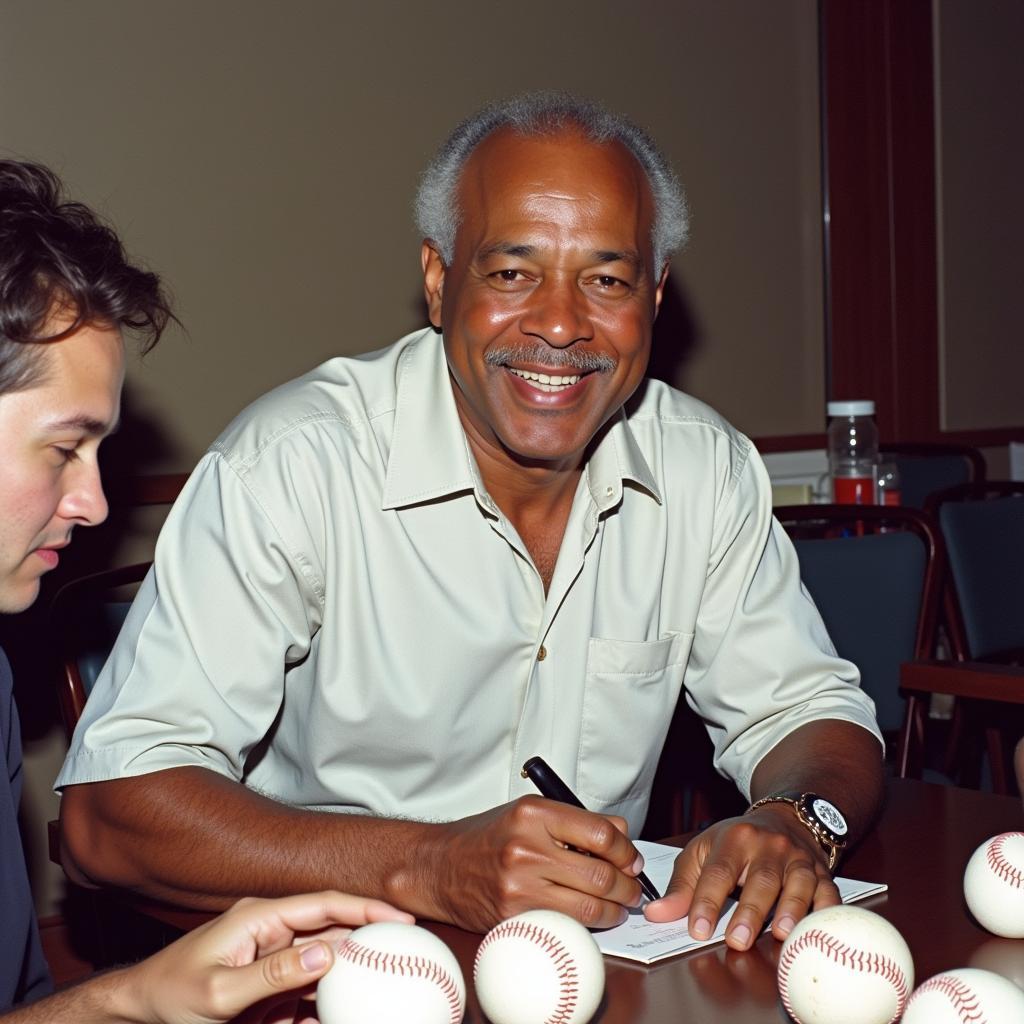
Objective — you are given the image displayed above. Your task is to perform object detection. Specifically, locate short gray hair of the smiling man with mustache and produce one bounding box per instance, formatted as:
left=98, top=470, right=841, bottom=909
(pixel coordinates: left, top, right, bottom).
left=415, top=92, right=689, bottom=274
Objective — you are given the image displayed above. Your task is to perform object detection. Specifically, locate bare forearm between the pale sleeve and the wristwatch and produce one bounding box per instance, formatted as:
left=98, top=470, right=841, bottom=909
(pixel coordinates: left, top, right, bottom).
left=751, top=719, right=884, bottom=842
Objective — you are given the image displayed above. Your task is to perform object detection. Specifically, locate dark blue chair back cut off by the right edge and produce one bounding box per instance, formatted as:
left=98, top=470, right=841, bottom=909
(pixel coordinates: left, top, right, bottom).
left=929, top=480, right=1024, bottom=663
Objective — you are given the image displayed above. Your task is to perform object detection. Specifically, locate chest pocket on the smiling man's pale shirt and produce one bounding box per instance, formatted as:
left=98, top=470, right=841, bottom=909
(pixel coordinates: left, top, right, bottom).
left=577, top=633, right=693, bottom=811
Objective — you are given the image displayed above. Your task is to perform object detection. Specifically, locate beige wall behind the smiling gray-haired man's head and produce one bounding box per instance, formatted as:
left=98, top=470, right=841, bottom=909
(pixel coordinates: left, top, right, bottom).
left=0, top=0, right=823, bottom=911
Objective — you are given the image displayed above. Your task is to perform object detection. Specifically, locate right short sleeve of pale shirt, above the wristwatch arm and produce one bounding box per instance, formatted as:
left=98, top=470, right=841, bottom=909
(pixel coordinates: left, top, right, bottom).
left=685, top=449, right=882, bottom=797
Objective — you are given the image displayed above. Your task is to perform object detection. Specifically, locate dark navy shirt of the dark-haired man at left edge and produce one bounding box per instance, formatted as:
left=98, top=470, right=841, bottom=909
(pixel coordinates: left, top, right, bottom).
left=0, top=648, right=53, bottom=1013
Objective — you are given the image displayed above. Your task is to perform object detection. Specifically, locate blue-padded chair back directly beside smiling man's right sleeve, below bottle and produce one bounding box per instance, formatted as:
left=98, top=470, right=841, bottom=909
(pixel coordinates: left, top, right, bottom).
left=774, top=505, right=944, bottom=743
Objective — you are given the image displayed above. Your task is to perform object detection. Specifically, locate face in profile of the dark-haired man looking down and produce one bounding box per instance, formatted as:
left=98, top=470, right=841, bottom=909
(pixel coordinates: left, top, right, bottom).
left=0, top=319, right=124, bottom=612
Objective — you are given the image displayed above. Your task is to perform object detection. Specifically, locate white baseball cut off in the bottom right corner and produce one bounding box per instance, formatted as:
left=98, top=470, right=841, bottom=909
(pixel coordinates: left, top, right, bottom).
left=902, top=967, right=1024, bottom=1024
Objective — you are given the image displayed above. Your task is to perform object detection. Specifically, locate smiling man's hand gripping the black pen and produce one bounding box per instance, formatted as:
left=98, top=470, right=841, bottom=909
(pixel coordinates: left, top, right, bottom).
left=411, top=796, right=643, bottom=932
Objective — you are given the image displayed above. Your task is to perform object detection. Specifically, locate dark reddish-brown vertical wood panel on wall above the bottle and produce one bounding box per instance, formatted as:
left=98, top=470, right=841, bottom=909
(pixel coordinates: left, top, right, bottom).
left=820, top=0, right=938, bottom=439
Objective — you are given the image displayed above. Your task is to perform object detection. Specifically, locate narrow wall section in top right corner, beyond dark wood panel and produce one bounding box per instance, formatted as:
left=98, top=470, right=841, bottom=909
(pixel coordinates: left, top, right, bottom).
left=935, top=0, right=1024, bottom=430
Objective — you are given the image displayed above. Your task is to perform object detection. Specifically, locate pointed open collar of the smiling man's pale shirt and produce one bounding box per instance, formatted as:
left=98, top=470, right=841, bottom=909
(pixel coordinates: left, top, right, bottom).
left=381, top=328, right=662, bottom=516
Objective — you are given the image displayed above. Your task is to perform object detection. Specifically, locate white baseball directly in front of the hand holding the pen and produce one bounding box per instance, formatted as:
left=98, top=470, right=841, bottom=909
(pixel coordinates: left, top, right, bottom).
left=473, top=910, right=604, bottom=1024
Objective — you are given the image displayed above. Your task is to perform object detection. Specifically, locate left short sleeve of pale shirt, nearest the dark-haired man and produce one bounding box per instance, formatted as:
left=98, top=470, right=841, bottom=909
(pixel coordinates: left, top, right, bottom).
left=55, top=452, right=322, bottom=788
